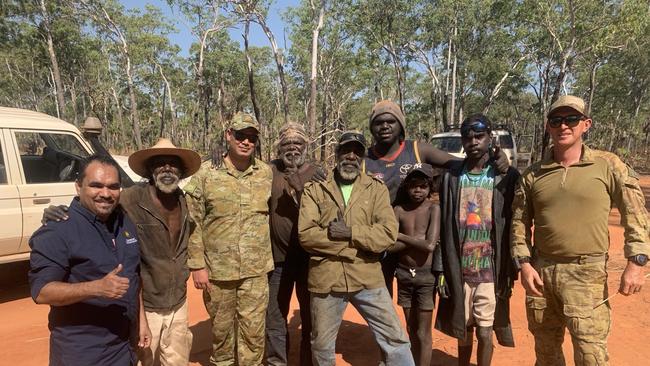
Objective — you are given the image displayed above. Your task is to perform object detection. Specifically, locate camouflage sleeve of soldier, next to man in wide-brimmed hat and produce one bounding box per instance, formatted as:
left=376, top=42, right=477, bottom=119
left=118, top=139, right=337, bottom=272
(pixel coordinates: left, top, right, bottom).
left=184, top=167, right=205, bottom=269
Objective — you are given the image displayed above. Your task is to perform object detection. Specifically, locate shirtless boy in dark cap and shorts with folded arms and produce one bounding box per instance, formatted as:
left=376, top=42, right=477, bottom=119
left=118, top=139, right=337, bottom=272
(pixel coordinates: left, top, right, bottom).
left=391, top=163, right=440, bottom=366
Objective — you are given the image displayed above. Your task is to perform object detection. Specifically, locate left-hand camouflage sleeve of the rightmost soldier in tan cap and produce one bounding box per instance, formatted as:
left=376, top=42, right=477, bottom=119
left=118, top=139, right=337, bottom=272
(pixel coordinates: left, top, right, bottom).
left=510, top=173, right=533, bottom=258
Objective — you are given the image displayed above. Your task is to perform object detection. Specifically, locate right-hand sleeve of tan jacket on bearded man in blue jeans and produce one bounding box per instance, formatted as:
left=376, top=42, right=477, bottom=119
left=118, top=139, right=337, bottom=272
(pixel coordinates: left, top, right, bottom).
left=352, top=182, right=398, bottom=253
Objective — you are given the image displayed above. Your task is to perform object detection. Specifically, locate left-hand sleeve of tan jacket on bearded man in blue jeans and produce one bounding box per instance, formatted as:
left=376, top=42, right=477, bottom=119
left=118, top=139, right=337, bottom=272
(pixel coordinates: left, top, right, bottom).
left=298, top=184, right=357, bottom=261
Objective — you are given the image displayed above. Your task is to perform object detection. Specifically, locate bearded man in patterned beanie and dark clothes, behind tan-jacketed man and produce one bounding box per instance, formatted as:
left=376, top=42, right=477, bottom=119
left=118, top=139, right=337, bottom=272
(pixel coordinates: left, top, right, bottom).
left=266, top=122, right=320, bottom=366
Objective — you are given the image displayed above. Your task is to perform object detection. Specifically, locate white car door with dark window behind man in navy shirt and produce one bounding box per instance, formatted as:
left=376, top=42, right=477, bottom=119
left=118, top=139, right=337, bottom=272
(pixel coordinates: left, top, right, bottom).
left=11, top=130, right=90, bottom=251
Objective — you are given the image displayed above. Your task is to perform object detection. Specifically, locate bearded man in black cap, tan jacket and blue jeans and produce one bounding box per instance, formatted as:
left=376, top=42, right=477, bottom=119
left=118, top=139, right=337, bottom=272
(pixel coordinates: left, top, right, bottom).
left=298, top=131, right=414, bottom=366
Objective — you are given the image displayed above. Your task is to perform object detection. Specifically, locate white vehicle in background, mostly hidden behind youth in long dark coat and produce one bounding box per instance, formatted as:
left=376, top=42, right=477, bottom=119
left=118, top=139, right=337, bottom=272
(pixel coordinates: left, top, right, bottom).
left=431, top=127, right=517, bottom=167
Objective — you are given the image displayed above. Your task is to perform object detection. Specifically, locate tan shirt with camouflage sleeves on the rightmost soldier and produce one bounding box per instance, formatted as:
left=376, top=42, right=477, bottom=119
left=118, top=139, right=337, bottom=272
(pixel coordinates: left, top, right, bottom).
left=511, top=145, right=650, bottom=258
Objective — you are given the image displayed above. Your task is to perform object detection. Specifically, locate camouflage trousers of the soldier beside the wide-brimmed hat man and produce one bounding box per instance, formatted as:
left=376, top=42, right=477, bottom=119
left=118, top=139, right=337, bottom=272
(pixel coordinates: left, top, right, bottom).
left=203, top=275, right=269, bottom=366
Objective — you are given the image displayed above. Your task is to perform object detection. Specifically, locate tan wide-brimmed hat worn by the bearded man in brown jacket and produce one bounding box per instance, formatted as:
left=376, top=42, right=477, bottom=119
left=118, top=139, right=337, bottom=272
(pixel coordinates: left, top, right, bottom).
left=129, top=138, right=201, bottom=179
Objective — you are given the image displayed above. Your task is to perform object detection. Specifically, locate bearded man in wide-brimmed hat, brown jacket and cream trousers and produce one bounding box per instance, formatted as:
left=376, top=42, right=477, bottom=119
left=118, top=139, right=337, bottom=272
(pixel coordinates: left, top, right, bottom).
left=44, top=139, right=201, bottom=366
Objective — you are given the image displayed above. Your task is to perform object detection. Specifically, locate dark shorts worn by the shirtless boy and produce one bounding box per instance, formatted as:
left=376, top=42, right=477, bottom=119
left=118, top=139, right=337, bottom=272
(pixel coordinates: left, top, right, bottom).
left=395, top=264, right=436, bottom=310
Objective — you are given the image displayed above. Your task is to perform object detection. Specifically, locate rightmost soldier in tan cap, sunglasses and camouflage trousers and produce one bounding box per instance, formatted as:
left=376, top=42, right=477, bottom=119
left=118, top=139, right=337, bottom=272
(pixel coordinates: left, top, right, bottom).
left=511, top=95, right=650, bottom=365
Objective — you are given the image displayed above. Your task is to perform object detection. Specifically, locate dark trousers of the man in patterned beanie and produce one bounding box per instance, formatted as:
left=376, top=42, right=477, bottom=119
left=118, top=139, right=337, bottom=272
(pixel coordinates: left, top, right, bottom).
left=266, top=260, right=312, bottom=366
